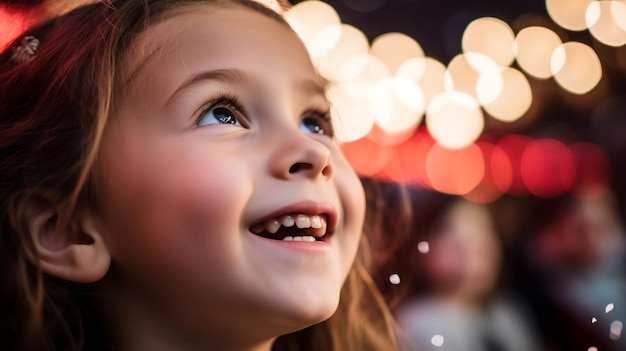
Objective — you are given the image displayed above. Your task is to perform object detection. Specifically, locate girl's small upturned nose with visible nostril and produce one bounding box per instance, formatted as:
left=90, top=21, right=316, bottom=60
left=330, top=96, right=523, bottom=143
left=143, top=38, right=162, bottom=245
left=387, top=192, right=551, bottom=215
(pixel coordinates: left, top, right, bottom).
left=270, top=131, right=333, bottom=180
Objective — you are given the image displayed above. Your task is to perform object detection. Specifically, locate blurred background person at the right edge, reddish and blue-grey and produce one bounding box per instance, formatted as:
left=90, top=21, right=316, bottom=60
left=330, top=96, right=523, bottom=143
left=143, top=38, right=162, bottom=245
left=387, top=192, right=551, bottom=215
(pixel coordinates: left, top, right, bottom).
left=518, top=193, right=626, bottom=351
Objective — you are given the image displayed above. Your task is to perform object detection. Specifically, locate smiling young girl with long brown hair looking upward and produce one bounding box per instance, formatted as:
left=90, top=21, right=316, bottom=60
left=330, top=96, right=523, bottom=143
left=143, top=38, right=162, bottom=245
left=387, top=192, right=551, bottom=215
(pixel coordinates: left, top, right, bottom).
left=0, top=0, right=397, bottom=351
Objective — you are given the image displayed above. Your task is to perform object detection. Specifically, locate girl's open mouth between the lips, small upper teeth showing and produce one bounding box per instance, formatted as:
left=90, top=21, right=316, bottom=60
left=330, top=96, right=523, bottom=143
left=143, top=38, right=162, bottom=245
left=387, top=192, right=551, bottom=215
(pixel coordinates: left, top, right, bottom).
left=250, top=213, right=328, bottom=242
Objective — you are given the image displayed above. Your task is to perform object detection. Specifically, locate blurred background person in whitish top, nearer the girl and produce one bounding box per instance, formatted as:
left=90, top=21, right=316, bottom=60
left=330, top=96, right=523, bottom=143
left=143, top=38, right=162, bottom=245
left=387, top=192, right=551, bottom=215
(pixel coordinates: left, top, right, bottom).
left=396, top=197, right=539, bottom=351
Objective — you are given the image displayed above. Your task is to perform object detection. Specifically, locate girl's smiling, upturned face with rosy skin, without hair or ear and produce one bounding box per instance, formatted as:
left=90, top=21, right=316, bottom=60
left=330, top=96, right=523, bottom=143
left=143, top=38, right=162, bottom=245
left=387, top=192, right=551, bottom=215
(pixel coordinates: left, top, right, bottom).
left=94, top=5, right=364, bottom=349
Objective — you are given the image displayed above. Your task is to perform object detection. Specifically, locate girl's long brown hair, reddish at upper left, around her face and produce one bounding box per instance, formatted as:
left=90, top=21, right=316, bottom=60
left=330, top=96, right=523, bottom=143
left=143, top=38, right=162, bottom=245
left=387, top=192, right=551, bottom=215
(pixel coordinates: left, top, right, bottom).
left=0, top=0, right=397, bottom=351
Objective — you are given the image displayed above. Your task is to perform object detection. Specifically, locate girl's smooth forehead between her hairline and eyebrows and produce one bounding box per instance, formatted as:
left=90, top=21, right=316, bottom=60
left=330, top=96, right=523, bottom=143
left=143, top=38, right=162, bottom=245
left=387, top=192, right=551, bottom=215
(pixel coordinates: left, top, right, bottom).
left=121, top=3, right=312, bottom=89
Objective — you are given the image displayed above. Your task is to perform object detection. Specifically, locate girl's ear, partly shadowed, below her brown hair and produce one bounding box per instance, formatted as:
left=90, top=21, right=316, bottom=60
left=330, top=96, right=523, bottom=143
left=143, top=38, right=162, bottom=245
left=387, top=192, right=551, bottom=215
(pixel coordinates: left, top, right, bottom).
left=22, top=199, right=111, bottom=283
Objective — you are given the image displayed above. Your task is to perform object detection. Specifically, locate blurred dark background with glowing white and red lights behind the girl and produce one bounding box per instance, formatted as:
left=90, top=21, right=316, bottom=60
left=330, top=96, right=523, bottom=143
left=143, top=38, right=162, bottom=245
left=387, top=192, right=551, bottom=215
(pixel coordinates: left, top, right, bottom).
left=0, top=0, right=626, bottom=351
